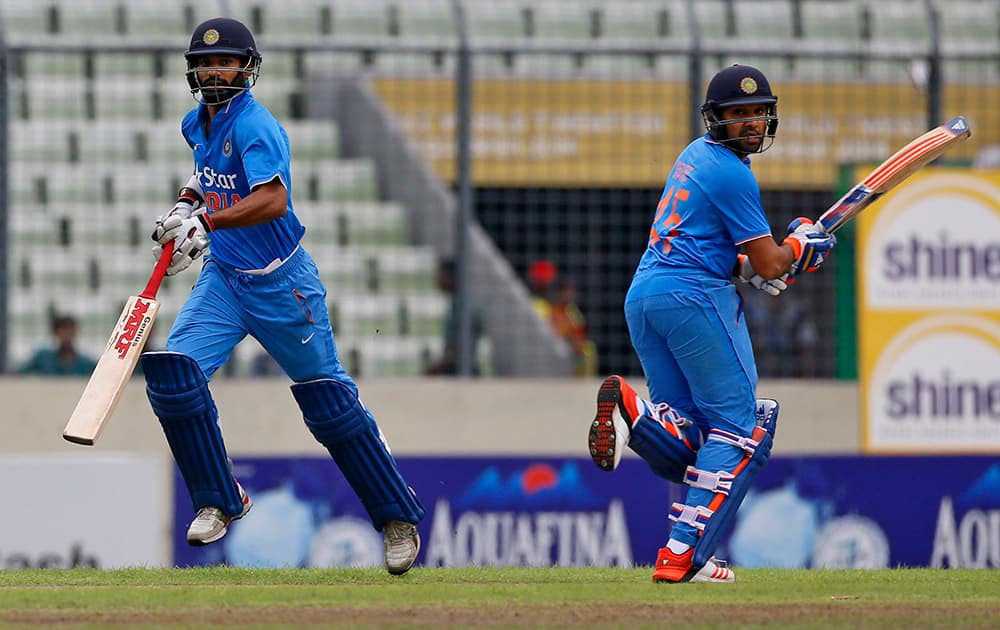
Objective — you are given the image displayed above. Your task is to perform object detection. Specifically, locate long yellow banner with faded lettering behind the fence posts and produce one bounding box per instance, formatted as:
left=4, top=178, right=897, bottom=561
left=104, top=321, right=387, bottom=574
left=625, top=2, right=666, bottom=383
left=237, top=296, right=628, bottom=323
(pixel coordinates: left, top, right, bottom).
left=374, top=78, right=1000, bottom=189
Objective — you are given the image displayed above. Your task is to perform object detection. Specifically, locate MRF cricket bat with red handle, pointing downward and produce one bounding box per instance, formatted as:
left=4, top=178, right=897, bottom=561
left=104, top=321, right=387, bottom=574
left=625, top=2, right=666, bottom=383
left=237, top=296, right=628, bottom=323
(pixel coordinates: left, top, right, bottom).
left=63, top=242, right=174, bottom=446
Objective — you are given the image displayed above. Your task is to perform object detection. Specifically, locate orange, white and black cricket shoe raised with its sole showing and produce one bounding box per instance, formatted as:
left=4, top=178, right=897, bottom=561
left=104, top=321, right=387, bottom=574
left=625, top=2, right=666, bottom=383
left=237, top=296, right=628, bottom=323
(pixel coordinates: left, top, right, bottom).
left=587, top=375, right=640, bottom=472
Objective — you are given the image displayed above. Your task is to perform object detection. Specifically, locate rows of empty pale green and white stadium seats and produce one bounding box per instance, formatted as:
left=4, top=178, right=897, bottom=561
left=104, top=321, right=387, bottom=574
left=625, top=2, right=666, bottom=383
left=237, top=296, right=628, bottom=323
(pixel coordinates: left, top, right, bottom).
left=0, top=0, right=1000, bottom=376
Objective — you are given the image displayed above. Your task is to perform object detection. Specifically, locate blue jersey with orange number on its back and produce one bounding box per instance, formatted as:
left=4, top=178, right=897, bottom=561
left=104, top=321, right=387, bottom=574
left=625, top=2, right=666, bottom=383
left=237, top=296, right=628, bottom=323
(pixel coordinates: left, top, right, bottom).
left=629, top=134, right=771, bottom=298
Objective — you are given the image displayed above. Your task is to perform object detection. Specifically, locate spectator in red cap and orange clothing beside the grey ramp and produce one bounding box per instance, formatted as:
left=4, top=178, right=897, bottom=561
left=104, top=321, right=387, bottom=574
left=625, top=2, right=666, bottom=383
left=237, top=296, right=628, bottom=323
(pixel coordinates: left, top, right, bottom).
left=528, top=260, right=597, bottom=377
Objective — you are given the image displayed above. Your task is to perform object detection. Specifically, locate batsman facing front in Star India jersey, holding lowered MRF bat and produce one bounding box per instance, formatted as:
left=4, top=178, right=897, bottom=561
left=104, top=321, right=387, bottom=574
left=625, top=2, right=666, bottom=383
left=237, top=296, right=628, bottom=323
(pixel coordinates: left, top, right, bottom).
left=142, top=18, right=424, bottom=574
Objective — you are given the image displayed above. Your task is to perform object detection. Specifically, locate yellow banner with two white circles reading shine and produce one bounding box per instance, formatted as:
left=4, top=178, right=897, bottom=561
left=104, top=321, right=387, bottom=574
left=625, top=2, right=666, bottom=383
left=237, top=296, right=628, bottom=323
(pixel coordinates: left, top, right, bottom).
left=857, top=168, right=1000, bottom=453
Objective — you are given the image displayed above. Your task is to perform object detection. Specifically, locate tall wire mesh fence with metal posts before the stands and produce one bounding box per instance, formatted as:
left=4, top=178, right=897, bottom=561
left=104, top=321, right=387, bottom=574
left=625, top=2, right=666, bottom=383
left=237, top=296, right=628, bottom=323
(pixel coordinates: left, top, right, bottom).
left=0, top=0, right=1000, bottom=378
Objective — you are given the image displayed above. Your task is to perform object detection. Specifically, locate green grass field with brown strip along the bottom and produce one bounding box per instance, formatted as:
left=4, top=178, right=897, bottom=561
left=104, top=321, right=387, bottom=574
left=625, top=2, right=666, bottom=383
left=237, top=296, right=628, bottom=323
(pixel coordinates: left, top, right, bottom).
left=0, top=567, right=1000, bottom=630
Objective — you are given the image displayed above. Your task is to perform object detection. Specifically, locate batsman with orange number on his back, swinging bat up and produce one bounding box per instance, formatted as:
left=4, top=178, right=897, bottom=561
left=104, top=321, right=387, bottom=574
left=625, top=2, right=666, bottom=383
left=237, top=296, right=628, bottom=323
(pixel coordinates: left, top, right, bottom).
left=588, top=65, right=836, bottom=582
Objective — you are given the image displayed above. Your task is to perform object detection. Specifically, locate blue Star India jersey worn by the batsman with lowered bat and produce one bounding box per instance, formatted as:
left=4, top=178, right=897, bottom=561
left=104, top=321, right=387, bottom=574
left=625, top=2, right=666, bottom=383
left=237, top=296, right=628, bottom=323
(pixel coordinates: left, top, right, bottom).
left=181, top=90, right=305, bottom=270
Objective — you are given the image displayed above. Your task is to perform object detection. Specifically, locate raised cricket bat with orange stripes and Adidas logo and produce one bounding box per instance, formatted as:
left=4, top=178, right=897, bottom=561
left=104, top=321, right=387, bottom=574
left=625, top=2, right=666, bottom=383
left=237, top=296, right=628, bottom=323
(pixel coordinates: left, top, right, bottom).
left=816, top=116, right=972, bottom=234
